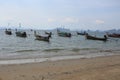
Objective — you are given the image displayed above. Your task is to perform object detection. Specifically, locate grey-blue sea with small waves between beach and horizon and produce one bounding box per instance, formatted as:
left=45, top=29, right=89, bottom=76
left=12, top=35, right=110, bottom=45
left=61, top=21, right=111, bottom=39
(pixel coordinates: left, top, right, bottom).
left=0, top=29, right=120, bottom=65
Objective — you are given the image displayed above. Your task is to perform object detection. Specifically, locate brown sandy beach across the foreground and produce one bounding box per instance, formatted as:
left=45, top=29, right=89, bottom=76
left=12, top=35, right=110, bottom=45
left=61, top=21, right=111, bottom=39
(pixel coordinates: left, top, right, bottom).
left=0, top=56, right=120, bottom=80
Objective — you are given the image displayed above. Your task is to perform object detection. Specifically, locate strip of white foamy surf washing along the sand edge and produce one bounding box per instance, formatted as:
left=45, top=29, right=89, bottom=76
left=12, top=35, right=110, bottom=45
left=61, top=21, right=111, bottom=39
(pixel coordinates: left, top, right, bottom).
left=0, top=54, right=114, bottom=65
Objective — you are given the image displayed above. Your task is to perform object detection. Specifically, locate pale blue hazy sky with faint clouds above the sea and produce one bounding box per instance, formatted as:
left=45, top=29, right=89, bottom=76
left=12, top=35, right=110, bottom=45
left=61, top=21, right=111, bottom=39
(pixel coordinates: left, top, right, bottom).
left=0, top=0, right=120, bottom=30
